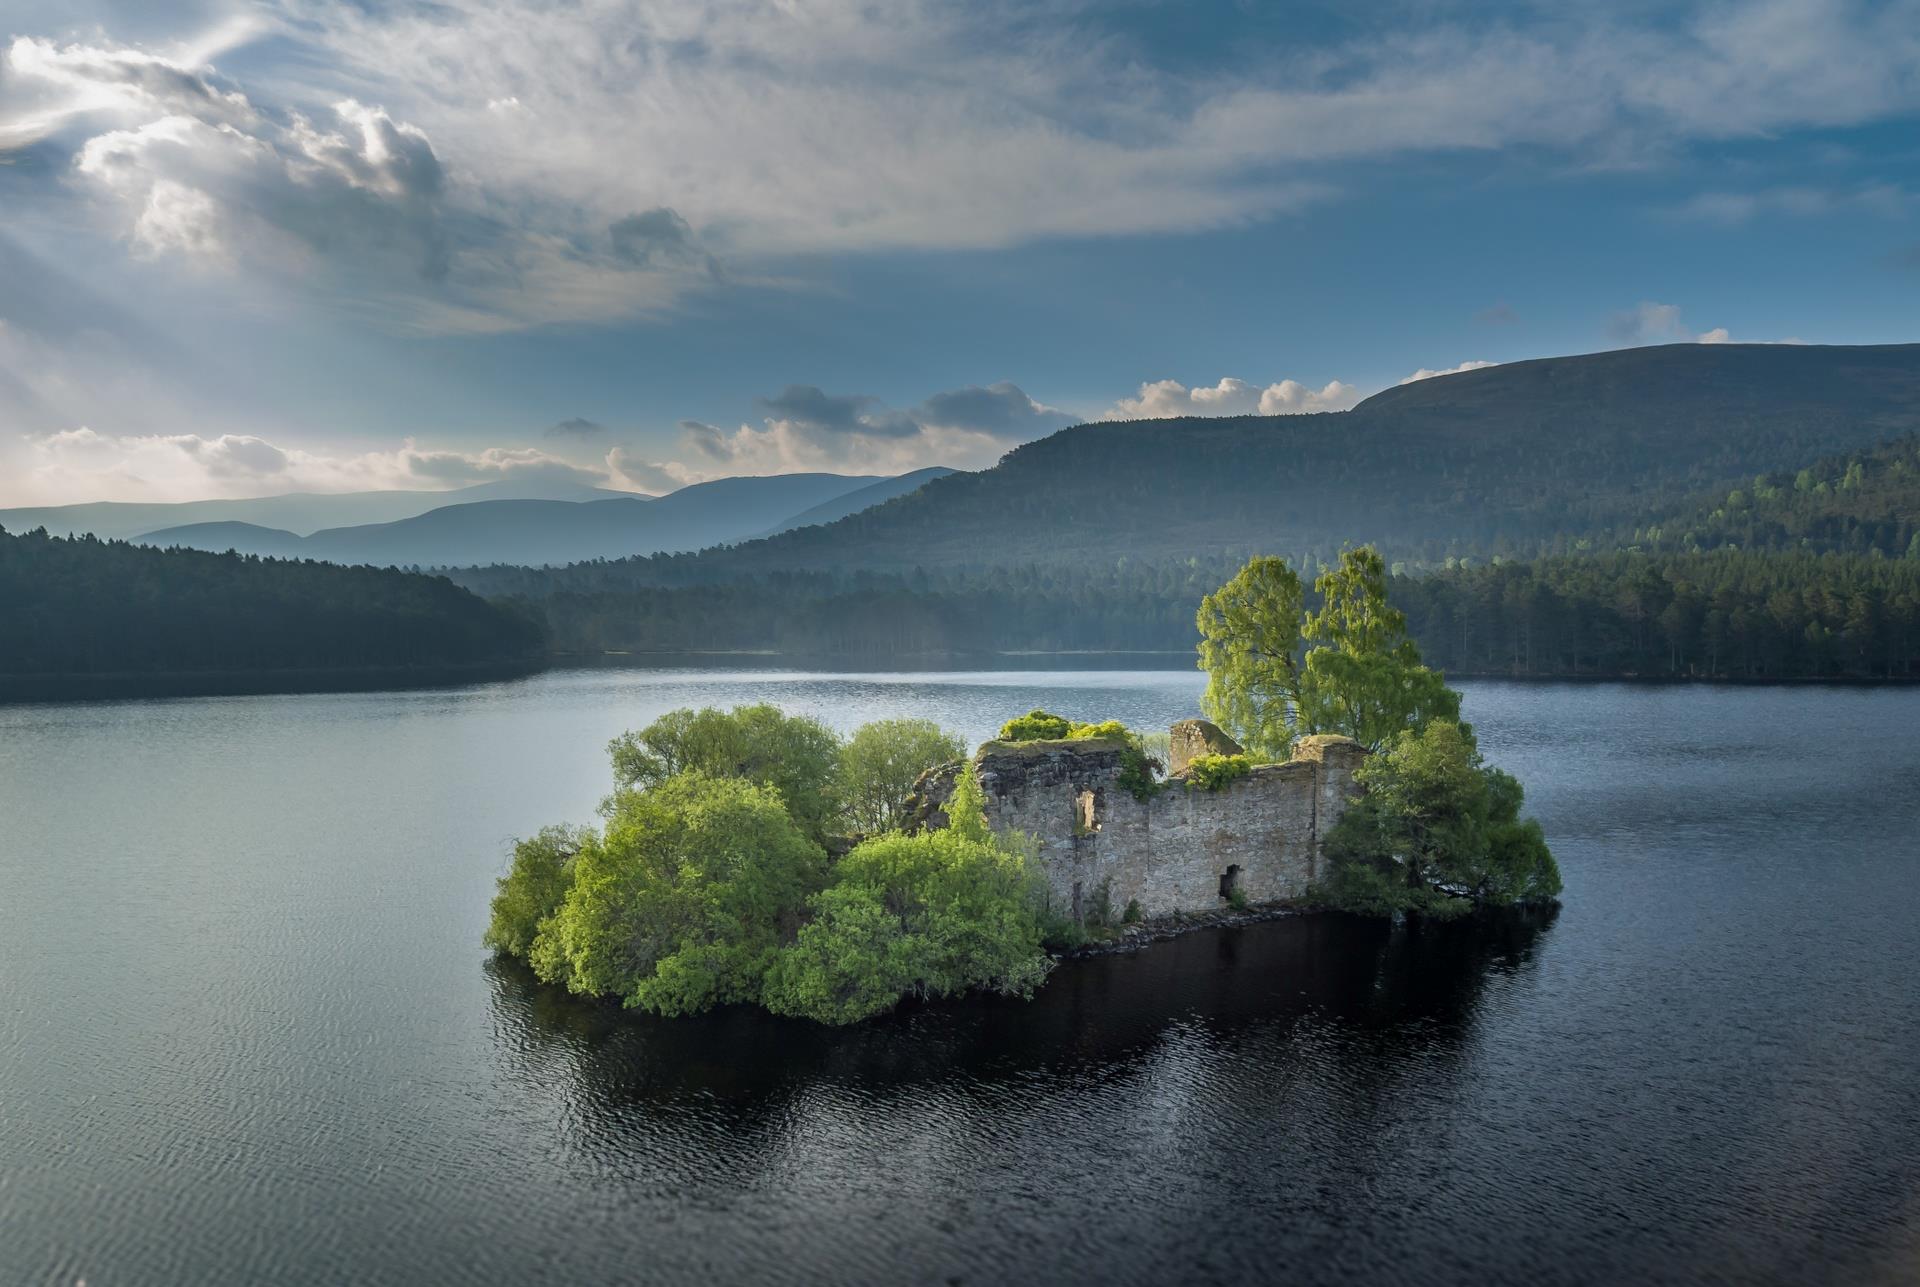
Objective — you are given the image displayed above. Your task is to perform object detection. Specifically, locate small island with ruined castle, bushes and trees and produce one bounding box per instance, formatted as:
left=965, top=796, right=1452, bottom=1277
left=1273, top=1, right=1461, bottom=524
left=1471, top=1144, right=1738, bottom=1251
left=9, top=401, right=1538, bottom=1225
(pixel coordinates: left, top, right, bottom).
left=486, top=547, right=1561, bottom=1024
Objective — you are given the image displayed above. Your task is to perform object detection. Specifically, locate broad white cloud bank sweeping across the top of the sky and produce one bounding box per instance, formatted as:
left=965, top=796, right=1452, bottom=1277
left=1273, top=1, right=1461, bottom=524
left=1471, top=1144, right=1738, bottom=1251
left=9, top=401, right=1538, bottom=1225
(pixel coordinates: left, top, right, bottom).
left=11, top=0, right=1920, bottom=330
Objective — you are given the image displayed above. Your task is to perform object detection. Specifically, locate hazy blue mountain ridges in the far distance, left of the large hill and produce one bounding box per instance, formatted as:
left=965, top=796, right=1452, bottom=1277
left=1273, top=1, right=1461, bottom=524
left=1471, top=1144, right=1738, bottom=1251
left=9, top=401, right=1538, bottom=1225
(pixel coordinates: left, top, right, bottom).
left=107, top=469, right=952, bottom=567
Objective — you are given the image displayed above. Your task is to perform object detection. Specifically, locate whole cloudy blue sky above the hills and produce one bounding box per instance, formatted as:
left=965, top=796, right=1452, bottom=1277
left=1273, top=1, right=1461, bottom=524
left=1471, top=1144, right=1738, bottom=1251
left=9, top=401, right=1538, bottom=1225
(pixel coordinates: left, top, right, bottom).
left=0, top=0, right=1920, bottom=505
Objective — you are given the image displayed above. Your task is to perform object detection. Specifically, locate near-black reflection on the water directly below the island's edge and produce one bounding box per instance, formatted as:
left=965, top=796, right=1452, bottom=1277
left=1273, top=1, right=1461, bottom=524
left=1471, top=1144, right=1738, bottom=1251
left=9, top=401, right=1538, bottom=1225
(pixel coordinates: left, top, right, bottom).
left=482, top=909, right=1559, bottom=1105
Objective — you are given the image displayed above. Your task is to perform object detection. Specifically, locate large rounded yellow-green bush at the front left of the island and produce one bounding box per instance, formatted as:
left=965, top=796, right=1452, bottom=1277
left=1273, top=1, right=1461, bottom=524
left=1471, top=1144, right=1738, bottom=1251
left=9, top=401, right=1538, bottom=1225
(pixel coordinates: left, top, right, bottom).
left=530, top=772, right=826, bottom=1014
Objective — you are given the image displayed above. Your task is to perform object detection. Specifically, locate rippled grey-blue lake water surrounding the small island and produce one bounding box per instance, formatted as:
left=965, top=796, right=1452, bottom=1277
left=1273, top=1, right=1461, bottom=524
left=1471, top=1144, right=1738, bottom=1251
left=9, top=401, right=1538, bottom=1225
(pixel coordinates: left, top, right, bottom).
left=0, top=670, right=1920, bottom=1287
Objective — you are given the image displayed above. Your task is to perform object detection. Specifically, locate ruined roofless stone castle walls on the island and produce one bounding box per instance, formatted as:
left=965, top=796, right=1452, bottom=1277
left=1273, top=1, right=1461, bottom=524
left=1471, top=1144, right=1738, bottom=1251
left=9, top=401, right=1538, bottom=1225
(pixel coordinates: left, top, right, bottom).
left=922, top=720, right=1367, bottom=920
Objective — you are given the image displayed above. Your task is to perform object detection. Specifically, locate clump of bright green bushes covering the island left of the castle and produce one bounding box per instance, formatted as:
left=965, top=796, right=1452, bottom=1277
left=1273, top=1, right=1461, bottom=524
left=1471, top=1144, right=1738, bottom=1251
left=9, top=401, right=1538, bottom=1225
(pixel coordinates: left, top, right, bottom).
left=484, top=707, right=1050, bottom=1024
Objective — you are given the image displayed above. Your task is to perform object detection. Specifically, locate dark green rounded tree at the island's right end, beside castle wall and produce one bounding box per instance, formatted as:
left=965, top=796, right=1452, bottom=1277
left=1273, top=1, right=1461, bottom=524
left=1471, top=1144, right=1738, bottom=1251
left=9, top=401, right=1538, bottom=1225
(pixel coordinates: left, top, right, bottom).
left=1321, top=720, right=1561, bottom=916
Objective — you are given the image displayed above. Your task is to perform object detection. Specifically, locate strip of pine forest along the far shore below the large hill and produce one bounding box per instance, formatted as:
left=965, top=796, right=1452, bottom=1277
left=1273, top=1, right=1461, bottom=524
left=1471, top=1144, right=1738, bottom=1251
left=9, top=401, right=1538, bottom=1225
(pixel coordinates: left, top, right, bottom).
left=495, top=549, right=1920, bottom=680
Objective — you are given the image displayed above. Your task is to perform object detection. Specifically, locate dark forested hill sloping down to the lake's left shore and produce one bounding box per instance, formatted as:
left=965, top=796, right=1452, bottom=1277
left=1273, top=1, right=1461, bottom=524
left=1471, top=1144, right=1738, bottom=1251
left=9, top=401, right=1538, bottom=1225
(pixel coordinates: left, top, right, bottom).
left=0, top=528, right=543, bottom=693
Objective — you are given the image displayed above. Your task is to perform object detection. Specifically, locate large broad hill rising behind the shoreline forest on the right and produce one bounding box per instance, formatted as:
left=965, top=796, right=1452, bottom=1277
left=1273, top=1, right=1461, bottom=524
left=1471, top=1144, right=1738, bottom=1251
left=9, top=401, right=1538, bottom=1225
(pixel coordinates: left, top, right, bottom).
left=499, top=344, right=1920, bottom=584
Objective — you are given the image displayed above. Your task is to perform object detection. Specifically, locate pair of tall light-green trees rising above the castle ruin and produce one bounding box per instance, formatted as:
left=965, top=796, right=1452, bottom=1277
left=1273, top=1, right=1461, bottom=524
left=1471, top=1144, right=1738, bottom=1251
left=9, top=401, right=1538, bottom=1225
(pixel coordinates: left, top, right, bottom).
left=1198, top=546, right=1459, bottom=759
